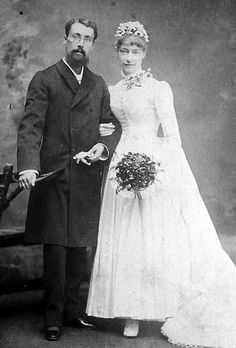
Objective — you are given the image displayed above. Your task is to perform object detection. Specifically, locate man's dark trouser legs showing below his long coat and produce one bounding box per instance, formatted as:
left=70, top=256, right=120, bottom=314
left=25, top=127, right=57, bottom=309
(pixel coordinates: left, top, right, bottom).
left=43, top=244, right=87, bottom=326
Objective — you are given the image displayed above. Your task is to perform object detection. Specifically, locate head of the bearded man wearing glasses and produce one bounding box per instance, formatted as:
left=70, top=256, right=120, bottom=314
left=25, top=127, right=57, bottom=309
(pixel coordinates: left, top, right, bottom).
left=65, top=23, right=94, bottom=65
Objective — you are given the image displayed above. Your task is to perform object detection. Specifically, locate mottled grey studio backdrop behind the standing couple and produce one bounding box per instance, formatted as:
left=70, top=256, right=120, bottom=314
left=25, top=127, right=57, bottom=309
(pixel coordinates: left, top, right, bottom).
left=0, top=0, right=236, bottom=252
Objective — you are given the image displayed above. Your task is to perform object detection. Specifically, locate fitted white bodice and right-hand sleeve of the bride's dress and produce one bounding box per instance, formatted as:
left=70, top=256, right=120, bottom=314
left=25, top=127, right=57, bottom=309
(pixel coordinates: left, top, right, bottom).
left=109, top=74, right=181, bottom=152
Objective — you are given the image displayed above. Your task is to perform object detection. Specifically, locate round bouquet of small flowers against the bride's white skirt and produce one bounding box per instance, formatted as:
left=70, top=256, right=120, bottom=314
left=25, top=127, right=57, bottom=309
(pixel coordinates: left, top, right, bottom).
left=111, top=152, right=161, bottom=199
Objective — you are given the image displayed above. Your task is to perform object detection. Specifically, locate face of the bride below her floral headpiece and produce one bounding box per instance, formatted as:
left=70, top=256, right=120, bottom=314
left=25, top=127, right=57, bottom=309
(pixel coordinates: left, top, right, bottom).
left=118, top=37, right=146, bottom=75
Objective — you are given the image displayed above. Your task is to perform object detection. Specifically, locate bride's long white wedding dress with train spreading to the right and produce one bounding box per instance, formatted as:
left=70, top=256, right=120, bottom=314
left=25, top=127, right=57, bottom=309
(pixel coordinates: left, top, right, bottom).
left=87, top=73, right=236, bottom=348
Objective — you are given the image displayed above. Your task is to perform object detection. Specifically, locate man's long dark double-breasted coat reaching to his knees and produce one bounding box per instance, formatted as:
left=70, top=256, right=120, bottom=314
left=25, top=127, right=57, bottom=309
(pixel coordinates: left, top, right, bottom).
left=17, top=60, right=119, bottom=247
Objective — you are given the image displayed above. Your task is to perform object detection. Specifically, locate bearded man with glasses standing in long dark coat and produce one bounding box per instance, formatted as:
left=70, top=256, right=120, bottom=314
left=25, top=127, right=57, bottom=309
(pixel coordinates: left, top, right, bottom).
left=17, top=19, right=119, bottom=341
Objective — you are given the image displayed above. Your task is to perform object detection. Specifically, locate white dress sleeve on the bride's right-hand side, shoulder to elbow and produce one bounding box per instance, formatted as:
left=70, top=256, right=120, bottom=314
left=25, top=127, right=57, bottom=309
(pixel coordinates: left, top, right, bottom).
left=155, top=81, right=181, bottom=146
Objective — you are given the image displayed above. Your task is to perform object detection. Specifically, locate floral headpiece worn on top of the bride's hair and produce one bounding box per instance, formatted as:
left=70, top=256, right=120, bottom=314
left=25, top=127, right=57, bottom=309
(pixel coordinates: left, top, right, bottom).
left=115, top=21, right=149, bottom=42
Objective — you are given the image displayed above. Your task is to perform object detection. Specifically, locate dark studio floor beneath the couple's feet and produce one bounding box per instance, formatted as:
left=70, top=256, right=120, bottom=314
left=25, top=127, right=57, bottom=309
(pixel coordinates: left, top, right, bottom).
left=0, top=290, right=176, bottom=348
